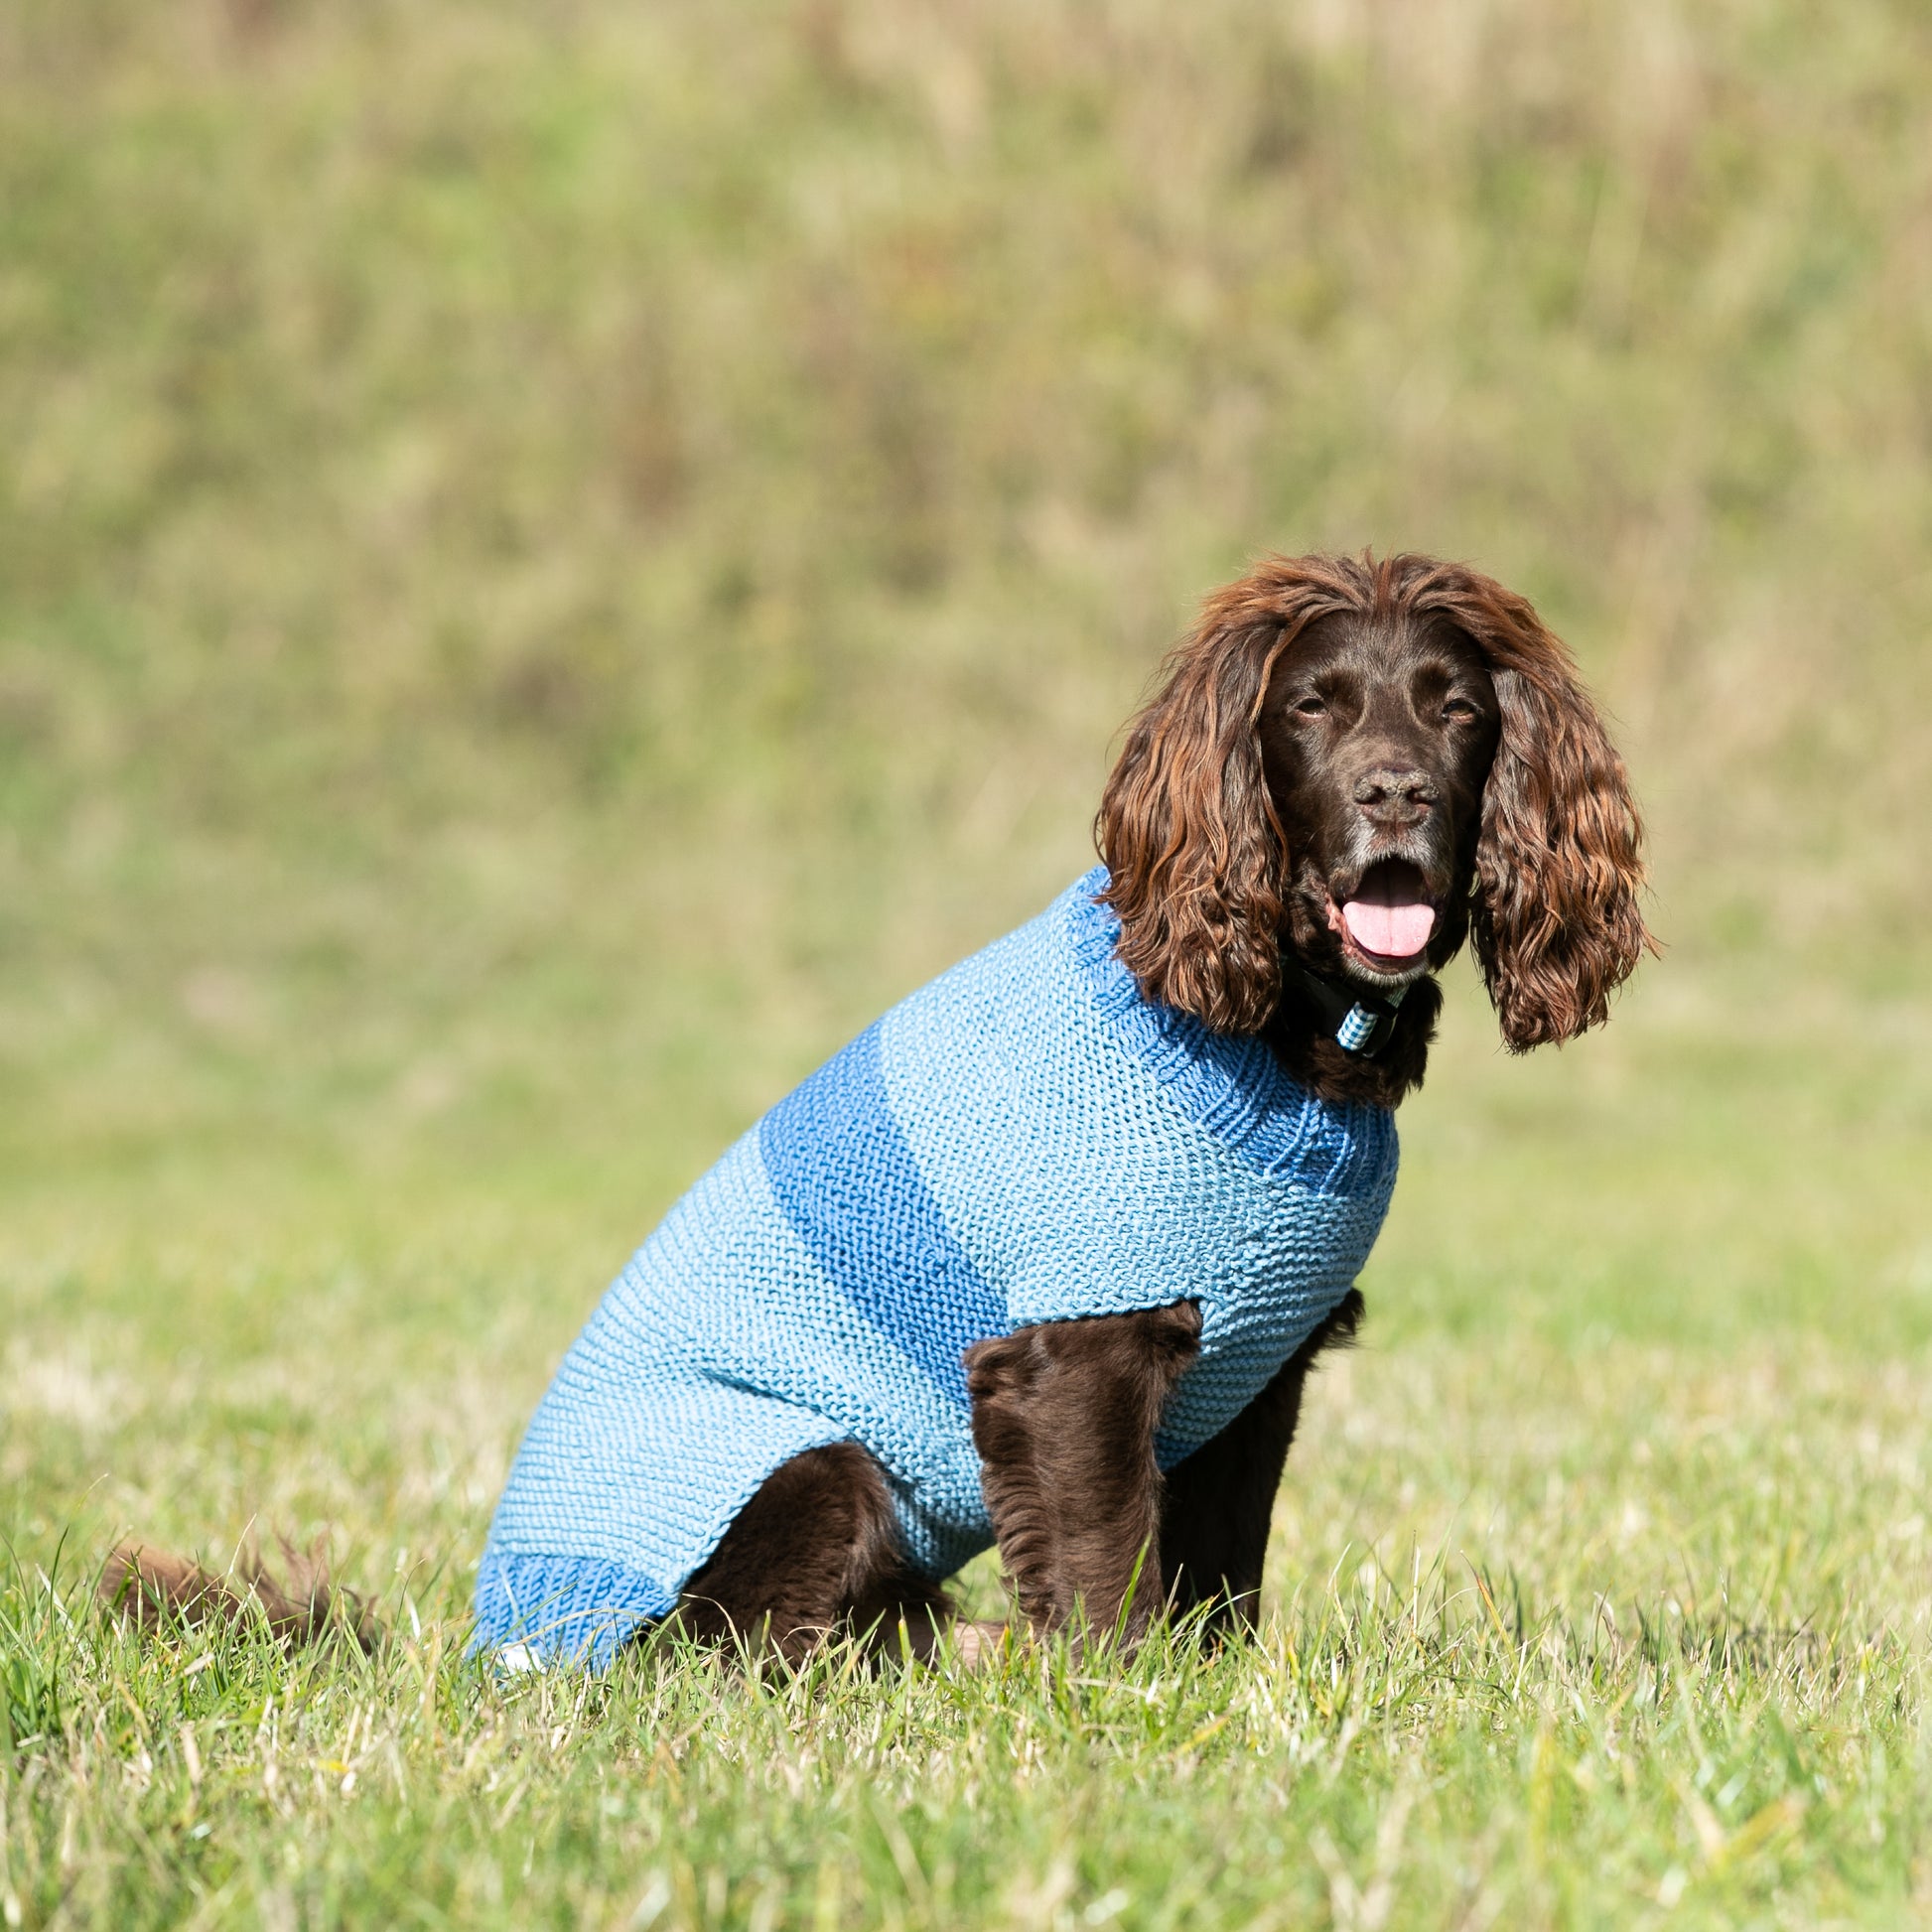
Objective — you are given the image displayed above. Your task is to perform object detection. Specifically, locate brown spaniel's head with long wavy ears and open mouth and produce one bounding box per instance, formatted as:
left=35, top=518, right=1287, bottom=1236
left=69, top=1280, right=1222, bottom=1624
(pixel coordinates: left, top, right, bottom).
left=1095, top=556, right=1648, bottom=1051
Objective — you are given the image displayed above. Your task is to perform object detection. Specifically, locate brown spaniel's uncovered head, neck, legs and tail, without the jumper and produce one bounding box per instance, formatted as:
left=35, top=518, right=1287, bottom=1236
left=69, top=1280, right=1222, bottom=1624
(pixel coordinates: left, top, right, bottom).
left=112, top=556, right=1648, bottom=1656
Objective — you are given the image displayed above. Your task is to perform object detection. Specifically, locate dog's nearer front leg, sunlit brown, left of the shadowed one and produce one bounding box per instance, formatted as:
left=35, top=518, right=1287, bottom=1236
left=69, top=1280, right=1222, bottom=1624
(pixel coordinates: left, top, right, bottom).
left=966, top=1303, right=1201, bottom=1642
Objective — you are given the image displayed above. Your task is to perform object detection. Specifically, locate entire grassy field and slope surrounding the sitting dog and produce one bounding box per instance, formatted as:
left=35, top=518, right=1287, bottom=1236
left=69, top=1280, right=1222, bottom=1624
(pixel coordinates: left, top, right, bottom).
left=0, top=0, right=1932, bottom=1928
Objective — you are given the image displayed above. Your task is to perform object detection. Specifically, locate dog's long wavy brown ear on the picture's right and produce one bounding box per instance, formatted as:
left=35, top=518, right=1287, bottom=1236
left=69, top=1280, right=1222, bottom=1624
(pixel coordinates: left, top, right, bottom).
left=1428, top=570, right=1656, bottom=1053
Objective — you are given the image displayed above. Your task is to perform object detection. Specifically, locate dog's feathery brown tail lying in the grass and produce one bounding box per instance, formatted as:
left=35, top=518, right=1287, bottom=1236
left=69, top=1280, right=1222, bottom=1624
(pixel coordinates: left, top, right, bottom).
left=98, top=1542, right=382, bottom=1650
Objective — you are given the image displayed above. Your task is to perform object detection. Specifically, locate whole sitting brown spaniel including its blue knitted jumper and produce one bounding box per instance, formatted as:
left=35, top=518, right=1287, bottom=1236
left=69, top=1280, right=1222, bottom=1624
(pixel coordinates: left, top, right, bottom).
left=110, top=555, right=1650, bottom=1667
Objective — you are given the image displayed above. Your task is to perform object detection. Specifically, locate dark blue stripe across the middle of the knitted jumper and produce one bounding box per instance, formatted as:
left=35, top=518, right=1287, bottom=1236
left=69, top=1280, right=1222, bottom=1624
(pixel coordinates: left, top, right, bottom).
left=758, top=1024, right=1007, bottom=1405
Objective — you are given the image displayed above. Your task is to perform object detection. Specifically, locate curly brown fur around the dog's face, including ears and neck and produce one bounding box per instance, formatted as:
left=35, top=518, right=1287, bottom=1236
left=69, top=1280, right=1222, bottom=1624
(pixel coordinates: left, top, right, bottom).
left=1095, top=555, right=1650, bottom=1103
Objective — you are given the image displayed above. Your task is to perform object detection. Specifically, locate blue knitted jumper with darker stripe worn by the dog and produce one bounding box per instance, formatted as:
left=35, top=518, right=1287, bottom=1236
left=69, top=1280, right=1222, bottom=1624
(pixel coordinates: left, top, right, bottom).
left=476, top=868, right=1397, bottom=1667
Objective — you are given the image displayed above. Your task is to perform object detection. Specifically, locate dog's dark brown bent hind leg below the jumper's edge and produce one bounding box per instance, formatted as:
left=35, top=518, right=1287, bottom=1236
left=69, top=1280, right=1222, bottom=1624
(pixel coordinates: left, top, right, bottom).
left=678, top=1442, right=950, bottom=1664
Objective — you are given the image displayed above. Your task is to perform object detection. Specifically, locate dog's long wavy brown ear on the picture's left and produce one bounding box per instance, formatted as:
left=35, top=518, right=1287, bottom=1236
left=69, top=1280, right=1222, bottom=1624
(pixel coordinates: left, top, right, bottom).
left=1093, top=558, right=1348, bottom=1034
